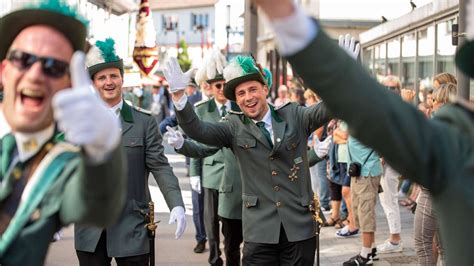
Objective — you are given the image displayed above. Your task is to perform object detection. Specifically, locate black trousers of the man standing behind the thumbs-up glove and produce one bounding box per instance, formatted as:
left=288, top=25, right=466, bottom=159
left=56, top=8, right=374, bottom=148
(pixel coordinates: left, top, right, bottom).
left=76, top=231, right=150, bottom=266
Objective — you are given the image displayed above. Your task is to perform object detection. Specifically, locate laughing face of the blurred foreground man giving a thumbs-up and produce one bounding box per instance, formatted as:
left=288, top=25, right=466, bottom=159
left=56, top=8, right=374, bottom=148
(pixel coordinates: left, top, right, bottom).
left=0, top=25, right=73, bottom=133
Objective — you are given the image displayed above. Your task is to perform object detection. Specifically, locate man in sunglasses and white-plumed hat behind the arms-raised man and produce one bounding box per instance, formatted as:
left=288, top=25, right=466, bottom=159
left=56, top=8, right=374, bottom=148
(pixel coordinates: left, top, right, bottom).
left=189, top=51, right=242, bottom=265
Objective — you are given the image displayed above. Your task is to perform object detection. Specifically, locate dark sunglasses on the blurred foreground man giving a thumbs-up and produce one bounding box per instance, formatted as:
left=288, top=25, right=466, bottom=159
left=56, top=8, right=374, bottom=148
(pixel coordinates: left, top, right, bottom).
left=7, top=50, right=69, bottom=78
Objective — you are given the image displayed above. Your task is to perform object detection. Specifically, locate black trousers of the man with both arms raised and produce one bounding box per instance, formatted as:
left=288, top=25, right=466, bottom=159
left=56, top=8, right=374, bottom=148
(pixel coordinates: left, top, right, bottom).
left=242, top=226, right=316, bottom=266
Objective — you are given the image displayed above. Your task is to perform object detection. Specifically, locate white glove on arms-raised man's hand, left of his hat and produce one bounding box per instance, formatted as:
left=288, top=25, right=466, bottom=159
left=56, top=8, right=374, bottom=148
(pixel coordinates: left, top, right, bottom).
left=163, top=57, right=196, bottom=93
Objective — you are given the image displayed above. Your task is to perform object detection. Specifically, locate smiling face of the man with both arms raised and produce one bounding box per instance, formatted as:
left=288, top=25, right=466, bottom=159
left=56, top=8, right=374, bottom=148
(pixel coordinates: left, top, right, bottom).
left=235, top=80, right=268, bottom=121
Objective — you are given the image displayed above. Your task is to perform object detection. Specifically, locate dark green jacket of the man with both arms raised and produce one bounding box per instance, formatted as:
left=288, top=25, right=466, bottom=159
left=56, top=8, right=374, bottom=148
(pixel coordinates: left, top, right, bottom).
left=176, top=103, right=329, bottom=244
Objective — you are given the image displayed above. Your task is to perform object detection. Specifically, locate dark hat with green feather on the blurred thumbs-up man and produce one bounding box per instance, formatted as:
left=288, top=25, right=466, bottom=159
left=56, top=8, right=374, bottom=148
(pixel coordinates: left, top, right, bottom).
left=0, top=0, right=88, bottom=61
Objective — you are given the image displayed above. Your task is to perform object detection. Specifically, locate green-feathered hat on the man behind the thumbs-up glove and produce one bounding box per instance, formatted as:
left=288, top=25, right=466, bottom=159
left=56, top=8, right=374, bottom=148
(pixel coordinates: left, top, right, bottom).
left=86, top=38, right=123, bottom=78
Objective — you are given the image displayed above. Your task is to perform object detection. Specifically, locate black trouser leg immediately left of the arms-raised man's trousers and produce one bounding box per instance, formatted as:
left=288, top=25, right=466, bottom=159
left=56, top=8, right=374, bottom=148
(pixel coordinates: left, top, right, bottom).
left=220, top=217, right=243, bottom=266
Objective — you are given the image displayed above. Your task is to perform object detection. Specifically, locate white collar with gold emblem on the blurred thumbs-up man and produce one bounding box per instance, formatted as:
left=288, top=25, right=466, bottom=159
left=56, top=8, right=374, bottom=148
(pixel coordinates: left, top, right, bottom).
left=13, top=124, right=54, bottom=162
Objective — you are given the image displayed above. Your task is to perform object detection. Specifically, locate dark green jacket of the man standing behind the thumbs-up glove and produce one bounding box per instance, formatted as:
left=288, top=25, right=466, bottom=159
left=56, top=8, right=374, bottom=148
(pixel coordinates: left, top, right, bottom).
left=74, top=102, right=184, bottom=257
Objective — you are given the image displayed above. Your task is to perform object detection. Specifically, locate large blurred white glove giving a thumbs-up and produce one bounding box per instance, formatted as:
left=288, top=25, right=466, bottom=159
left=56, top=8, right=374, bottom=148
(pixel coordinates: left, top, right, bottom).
left=52, top=52, right=121, bottom=164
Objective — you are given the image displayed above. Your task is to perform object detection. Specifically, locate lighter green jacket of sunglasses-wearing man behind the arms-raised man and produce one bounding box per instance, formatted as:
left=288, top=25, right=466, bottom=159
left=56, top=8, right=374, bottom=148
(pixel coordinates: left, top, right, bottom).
left=189, top=98, right=238, bottom=190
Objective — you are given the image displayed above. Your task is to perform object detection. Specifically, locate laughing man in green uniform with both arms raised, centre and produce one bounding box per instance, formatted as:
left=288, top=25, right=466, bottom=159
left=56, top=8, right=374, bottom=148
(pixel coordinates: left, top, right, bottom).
left=164, top=56, right=330, bottom=265
